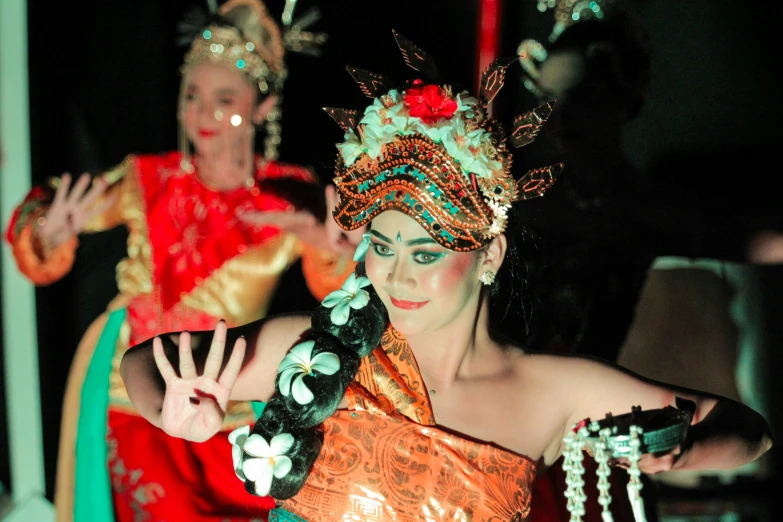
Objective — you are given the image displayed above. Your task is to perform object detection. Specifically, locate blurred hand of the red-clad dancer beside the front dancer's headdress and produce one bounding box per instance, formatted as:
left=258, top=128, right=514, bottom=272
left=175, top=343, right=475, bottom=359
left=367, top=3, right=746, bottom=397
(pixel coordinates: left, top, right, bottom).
left=239, top=185, right=366, bottom=256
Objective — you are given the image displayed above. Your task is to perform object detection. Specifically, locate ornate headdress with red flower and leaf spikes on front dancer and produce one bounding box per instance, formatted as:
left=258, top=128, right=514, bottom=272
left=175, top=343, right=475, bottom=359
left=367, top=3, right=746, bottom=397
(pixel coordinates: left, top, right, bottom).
left=325, top=32, right=563, bottom=252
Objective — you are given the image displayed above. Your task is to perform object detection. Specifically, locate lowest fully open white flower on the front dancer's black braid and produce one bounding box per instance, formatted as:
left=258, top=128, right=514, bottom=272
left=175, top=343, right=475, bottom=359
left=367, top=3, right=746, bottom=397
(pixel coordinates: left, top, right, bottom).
left=242, top=427, right=294, bottom=497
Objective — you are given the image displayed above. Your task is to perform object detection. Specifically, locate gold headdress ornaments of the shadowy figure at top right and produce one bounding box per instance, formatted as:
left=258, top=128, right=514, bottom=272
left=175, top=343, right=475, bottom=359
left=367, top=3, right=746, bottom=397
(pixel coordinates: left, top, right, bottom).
left=517, top=0, right=618, bottom=94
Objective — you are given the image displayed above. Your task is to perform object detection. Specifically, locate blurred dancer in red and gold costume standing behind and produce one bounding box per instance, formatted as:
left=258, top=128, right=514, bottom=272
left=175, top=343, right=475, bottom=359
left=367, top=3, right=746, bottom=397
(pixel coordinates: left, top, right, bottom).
left=8, top=0, right=353, bottom=521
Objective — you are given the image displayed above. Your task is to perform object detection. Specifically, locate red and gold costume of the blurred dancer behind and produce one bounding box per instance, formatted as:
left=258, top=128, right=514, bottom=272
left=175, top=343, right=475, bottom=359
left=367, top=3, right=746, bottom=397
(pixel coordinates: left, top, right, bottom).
left=7, top=153, right=353, bottom=522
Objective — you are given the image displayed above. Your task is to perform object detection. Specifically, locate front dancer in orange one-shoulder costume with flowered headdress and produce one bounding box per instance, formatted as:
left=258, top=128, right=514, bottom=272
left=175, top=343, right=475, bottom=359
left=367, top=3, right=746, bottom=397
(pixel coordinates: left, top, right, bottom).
left=121, top=31, right=771, bottom=522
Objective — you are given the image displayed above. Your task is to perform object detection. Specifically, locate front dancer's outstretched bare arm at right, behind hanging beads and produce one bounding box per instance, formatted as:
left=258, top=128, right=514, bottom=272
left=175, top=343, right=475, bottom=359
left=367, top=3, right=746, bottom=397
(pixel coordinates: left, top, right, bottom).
left=560, top=358, right=772, bottom=473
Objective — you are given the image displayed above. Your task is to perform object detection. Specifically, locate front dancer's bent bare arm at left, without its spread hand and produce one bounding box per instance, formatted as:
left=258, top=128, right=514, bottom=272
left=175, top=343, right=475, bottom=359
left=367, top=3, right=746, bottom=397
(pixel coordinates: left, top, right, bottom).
left=120, top=315, right=310, bottom=427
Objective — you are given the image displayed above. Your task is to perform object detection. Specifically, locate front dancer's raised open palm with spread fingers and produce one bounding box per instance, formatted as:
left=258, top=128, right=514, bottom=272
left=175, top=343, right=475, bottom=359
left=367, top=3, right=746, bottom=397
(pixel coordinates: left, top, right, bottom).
left=152, top=321, right=246, bottom=442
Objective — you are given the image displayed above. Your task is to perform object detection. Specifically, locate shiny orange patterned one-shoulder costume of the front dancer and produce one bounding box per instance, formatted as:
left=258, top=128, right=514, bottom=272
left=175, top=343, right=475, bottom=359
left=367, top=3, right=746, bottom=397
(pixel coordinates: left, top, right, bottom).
left=273, top=326, right=536, bottom=522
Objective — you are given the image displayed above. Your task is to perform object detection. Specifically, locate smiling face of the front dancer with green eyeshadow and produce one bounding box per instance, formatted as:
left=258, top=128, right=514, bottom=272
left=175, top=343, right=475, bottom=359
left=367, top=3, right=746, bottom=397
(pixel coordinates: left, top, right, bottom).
left=366, top=211, right=481, bottom=335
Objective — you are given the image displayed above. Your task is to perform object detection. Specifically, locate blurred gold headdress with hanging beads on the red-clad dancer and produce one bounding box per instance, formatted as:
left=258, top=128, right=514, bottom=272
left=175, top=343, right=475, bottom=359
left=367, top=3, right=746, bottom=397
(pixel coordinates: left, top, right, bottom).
left=181, top=0, right=326, bottom=162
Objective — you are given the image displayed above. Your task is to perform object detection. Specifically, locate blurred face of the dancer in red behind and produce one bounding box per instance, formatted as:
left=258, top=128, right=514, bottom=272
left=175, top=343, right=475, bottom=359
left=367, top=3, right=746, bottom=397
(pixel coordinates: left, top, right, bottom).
left=181, top=62, right=258, bottom=155
